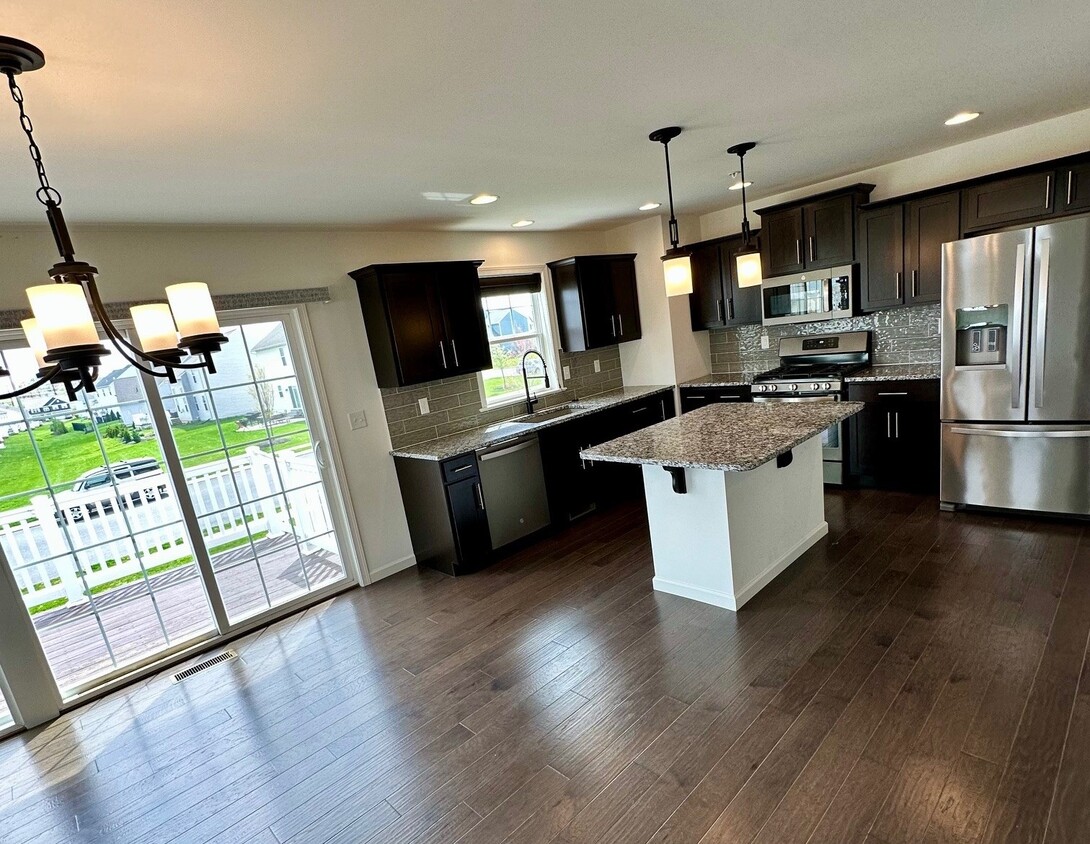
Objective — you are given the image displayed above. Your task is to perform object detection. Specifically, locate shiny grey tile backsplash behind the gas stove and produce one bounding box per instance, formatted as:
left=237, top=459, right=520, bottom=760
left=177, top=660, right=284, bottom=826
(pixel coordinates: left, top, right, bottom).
left=709, top=304, right=941, bottom=375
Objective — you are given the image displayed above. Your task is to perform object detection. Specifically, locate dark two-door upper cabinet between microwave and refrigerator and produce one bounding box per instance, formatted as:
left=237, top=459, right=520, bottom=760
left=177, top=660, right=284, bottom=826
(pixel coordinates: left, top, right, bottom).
left=858, top=193, right=959, bottom=311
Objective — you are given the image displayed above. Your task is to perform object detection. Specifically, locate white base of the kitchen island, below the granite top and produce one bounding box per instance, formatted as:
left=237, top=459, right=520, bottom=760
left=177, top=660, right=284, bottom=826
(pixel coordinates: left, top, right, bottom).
left=643, top=435, right=828, bottom=610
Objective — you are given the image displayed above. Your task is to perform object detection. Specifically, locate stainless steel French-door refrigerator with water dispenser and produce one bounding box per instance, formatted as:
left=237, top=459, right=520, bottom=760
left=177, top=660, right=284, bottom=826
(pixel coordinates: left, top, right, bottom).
left=940, top=217, right=1090, bottom=516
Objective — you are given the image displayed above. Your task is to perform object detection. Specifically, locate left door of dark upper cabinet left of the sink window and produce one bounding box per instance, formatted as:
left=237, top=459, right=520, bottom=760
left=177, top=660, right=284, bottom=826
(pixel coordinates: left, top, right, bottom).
left=380, top=269, right=453, bottom=385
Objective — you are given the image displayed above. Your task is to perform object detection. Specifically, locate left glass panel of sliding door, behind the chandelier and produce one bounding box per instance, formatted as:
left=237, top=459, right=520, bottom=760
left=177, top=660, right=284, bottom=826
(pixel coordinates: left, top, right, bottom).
left=0, top=349, right=213, bottom=694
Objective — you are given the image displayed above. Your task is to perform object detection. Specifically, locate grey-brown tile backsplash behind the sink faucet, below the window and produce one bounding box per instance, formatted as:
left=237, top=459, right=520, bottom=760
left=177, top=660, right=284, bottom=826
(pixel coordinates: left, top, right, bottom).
left=380, top=346, right=623, bottom=448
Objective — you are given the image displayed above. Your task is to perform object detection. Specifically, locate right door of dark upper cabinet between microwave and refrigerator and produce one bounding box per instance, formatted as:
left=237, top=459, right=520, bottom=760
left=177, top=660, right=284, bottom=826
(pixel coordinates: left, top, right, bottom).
left=905, top=193, right=961, bottom=304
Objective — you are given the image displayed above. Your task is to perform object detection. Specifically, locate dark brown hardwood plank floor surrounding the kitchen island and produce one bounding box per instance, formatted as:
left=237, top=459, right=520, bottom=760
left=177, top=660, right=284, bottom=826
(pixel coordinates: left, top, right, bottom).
left=0, top=492, right=1090, bottom=844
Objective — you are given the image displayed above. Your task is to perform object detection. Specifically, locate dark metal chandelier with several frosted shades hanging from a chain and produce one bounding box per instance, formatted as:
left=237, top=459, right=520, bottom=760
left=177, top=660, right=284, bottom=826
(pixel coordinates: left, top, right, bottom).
left=0, top=35, right=227, bottom=401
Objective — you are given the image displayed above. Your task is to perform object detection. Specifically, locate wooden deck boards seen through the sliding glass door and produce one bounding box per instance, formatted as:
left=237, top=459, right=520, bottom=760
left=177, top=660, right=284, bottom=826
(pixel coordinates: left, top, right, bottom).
left=28, top=535, right=344, bottom=693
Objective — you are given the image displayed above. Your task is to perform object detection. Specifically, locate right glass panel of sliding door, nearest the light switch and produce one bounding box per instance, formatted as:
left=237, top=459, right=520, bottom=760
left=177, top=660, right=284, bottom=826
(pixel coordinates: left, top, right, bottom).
left=160, top=319, right=346, bottom=623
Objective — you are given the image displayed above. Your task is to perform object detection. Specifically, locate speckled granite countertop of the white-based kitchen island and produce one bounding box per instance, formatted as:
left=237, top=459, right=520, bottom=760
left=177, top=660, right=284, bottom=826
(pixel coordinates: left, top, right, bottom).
left=580, top=401, right=864, bottom=472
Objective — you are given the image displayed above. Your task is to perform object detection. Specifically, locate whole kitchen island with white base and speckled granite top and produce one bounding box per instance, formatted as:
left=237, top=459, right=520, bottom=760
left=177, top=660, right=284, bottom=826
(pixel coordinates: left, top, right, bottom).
left=580, top=401, right=863, bottom=610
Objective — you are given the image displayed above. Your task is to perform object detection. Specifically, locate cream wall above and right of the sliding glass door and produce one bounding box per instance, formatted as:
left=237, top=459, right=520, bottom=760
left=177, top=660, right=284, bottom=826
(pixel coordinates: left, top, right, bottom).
left=0, top=224, right=606, bottom=571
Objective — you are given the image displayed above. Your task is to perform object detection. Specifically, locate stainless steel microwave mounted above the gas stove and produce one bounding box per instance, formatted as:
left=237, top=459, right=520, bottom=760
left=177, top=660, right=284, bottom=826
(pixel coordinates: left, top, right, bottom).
left=761, top=264, right=858, bottom=325
